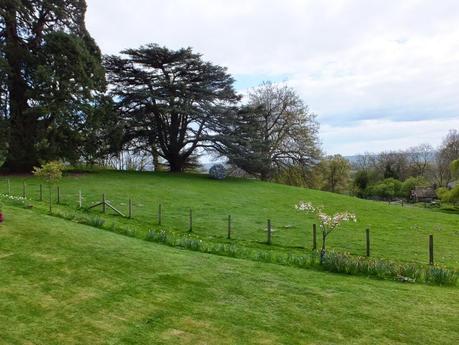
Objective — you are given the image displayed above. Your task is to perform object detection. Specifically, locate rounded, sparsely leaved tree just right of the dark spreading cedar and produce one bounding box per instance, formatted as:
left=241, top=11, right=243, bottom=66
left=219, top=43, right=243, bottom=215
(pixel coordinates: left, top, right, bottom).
left=213, top=82, right=320, bottom=180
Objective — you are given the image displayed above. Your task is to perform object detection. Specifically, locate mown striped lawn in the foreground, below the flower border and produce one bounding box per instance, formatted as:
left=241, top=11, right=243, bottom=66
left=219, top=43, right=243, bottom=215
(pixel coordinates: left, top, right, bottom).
left=0, top=208, right=459, bottom=345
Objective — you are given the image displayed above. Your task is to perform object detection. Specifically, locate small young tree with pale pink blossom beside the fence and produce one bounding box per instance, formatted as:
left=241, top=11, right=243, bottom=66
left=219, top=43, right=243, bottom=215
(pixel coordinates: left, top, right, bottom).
left=295, top=201, right=357, bottom=263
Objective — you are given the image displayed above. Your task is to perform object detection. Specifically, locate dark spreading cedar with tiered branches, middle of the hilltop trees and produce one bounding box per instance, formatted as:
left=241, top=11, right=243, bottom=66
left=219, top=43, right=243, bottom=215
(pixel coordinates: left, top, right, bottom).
left=105, top=44, right=238, bottom=172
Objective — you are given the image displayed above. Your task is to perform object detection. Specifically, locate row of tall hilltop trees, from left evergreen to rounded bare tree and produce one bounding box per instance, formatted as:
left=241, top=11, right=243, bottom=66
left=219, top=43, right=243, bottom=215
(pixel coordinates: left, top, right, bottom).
left=0, top=0, right=320, bottom=180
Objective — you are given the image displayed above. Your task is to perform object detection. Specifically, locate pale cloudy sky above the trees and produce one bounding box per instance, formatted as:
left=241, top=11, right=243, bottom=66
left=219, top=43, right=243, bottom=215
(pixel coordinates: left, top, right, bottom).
left=86, top=0, right=459, bottom=155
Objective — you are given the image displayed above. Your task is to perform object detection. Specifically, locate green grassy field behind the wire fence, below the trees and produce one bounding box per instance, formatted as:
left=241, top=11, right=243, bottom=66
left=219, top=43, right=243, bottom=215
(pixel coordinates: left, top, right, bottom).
left=0, top=172, right=459, bottom=267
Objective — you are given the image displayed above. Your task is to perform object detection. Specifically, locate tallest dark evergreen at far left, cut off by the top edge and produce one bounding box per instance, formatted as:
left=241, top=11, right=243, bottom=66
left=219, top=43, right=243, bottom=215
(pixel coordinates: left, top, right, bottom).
left=0, top=0, right=105, bottom=171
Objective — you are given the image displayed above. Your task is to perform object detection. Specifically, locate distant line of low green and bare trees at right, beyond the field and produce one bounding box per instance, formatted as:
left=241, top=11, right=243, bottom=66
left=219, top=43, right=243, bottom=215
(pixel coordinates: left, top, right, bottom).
left=298, top=130, right=459, bottom=201
